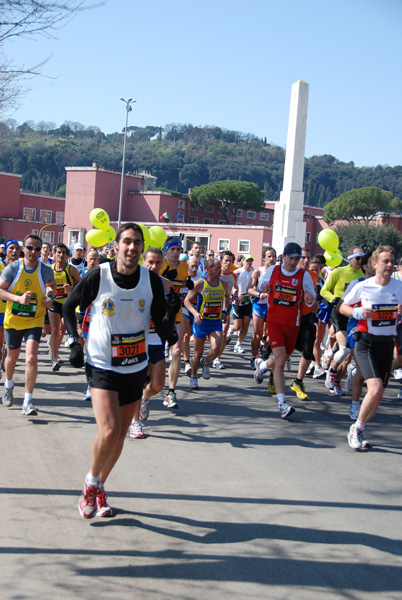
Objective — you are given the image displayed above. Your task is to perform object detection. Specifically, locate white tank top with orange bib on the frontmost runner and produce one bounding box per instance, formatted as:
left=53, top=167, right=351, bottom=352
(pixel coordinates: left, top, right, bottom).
left=87, top=263, right=153, bottom=373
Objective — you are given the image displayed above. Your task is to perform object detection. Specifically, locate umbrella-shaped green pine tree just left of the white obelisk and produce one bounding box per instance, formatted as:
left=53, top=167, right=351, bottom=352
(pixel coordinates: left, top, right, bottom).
left=190, top=180, right=265, bottom=225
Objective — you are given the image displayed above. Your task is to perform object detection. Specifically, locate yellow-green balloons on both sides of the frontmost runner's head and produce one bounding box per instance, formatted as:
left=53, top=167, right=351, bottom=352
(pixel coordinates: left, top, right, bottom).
left=85, top=208, right=167, bottom=250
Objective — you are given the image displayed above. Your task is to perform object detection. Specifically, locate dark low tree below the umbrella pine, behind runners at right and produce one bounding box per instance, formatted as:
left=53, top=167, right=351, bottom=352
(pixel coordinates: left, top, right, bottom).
left=335, top=223, right=402, bottom=257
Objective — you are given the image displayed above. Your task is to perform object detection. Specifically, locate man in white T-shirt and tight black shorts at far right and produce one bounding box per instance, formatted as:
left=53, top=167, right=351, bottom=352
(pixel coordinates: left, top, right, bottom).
left=340, top=246, right=402, bottom=450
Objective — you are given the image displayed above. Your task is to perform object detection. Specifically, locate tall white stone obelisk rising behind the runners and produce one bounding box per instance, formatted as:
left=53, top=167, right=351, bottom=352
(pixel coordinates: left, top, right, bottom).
left=272, top=80, right=309, bottom=254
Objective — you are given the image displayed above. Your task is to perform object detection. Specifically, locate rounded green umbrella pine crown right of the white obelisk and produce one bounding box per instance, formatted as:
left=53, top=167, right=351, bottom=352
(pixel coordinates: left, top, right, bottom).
left=324, top=187, right=402, bottom=223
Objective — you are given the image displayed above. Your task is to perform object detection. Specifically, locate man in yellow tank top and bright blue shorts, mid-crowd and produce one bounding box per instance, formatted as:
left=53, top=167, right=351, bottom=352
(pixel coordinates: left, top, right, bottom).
left=184, top=258, right=230, bottom=390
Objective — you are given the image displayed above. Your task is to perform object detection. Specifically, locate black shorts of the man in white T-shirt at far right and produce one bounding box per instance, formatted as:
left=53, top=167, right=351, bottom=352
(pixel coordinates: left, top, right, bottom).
left=355, top=333, right=394, bottom=387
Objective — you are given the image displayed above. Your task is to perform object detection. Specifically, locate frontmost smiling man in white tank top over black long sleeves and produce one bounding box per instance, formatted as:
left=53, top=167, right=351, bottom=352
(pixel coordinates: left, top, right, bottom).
left=63, top=223, right=174, bottom=519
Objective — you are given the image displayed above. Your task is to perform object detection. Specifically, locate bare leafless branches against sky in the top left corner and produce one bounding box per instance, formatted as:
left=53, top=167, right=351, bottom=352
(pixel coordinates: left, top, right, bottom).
left=0, top=0, right=83, bottom=115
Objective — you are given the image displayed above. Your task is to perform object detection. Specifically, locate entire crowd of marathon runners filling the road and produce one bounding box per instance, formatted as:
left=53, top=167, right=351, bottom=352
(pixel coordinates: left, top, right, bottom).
left=0, top=223, right=402, bottom=518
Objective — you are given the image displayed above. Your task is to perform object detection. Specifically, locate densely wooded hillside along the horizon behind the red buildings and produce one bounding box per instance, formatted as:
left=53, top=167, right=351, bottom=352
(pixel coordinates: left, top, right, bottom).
left=0, top=119, right=402, bottom=207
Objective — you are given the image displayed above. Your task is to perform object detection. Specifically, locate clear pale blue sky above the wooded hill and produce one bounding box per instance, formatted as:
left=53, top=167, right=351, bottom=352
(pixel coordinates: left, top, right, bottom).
left=5, top=0, right=402, bottom=167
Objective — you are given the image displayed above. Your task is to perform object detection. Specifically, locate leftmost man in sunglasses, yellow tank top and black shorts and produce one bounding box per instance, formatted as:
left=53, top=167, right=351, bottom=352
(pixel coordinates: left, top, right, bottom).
left=0, top=234, right=56, bottom=416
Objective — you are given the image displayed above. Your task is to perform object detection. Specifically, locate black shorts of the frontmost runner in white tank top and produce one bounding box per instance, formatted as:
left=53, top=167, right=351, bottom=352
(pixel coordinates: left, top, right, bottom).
left=85, top=363, right=148, bottom=406
